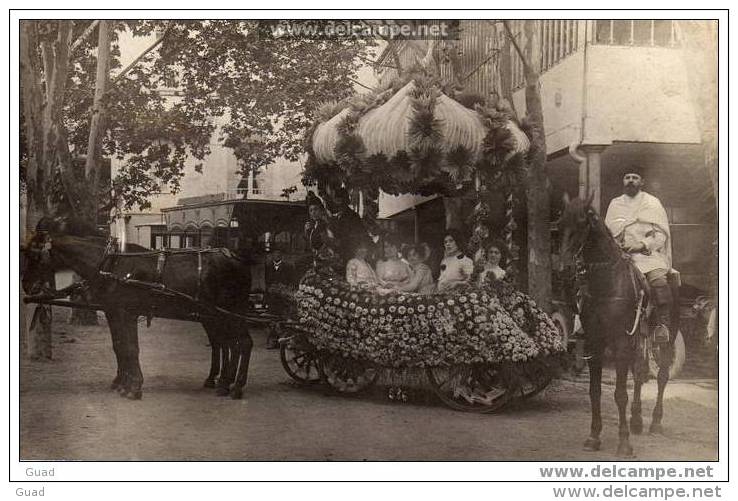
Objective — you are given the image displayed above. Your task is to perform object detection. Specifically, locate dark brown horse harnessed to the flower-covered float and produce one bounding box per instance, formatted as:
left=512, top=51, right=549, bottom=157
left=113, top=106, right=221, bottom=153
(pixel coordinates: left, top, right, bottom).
left=22, top=220, right=253, bottom=399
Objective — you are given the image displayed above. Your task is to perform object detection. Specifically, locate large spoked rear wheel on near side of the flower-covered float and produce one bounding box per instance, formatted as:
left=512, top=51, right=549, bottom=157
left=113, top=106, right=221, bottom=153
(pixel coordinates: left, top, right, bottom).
left=426, top=365, right=513, bottom=413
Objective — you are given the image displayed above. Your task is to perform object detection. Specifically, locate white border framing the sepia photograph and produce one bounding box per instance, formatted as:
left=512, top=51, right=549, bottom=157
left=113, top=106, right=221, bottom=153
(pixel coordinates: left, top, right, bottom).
left=2, top=2, right=736, bottom=499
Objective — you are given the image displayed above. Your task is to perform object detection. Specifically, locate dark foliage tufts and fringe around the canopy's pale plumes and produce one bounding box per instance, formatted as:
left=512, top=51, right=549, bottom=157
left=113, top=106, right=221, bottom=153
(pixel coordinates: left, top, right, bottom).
left=303, top=67, right=525, bottom=195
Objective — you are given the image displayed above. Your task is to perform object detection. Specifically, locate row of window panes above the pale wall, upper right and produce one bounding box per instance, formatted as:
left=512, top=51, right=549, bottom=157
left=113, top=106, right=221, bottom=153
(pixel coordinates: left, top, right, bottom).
left=594, top=19, right=678, bottom=47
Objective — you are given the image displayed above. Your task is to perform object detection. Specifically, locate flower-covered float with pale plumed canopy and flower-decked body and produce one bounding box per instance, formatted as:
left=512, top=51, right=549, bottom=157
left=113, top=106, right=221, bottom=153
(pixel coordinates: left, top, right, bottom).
left=281, top=58, right=564, bottom=412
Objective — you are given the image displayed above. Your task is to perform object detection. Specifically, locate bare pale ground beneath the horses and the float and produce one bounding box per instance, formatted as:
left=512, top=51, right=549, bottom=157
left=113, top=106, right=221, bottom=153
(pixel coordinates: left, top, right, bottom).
left=21, top=310, right=718, bottom=460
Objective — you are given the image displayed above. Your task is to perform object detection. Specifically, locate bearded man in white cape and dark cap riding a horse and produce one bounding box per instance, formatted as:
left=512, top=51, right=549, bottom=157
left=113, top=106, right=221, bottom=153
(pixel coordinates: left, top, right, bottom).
left=605, top=167, right=672, bottom=343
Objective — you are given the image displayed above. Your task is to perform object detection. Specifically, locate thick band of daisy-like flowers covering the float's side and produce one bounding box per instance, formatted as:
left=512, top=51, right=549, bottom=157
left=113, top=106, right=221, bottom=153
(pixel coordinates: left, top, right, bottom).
left=288, top=273, right=562, bottom=367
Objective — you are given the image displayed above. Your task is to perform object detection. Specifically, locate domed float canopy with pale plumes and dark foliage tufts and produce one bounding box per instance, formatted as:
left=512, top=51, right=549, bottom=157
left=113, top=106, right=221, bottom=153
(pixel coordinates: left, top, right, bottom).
left=305, top=69, right=530, bottom=194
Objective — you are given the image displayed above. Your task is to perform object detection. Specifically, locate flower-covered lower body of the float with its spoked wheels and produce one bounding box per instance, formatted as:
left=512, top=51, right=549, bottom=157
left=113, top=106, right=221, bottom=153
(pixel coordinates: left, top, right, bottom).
left=270, top=272, right=564, bottom=413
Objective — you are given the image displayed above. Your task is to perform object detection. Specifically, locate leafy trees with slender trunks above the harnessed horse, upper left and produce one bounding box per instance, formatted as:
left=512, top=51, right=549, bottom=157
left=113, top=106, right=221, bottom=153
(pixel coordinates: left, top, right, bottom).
left=21, top=20, right=373, bottom=228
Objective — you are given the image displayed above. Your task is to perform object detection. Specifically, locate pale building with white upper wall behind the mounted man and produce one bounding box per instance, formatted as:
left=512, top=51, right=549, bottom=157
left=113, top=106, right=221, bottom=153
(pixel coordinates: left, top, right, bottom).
left=378, top=20, right=717, bottom=290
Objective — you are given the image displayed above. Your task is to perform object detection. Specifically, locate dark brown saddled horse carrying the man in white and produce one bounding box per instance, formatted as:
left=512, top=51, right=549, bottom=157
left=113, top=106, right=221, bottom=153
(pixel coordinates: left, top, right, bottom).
left=559, top=197, right=676, bottom=457
